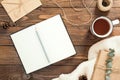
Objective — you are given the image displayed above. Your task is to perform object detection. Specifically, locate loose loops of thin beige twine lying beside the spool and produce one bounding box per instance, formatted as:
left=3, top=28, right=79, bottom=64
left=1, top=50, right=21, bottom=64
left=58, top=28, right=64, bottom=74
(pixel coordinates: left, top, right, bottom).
left=52, top=0, right=94, bottom=26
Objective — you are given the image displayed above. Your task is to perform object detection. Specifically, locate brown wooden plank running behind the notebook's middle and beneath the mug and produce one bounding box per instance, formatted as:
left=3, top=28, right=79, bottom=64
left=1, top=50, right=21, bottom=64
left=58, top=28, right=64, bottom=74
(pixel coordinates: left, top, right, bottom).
left=0, top=27, right=120, bottom=45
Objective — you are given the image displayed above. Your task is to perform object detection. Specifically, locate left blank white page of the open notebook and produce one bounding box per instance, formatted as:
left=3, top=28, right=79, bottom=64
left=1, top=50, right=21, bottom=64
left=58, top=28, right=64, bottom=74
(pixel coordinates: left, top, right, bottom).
left=11, top=25, right=48, bottom=74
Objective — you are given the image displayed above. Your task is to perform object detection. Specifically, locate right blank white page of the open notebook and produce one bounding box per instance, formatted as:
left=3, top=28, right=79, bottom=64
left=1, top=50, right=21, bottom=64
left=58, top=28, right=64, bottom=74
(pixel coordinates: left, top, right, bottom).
left=36, top=15, right=76, bottom=63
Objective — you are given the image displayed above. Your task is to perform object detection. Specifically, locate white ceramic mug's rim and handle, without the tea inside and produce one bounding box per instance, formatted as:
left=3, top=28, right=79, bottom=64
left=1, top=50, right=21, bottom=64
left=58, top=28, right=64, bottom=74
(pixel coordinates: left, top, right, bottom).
left=90, top=16, right=120, bottom=38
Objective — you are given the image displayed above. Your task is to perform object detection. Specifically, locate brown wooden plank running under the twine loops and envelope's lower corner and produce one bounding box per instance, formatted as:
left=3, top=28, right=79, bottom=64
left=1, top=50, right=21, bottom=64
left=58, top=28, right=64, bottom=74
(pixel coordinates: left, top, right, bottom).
left=0, top=8, right=120, bottom=23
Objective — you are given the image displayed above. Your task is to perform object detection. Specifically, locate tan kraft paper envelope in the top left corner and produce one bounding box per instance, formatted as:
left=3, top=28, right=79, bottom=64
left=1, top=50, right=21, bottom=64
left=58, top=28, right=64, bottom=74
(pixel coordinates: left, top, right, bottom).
left=1, top=0, right=42, bottom=22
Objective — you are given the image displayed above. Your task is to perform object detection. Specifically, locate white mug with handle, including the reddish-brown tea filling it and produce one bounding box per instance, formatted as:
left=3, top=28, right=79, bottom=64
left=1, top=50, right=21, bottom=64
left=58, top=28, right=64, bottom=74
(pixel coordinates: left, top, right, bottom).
left=90, top=16, right=120, bottom=38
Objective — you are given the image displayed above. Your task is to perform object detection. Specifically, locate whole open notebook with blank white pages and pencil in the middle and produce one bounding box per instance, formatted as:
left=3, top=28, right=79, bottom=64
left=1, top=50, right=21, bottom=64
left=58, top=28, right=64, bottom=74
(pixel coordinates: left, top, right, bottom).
left=10, top=15, right=76, bottom=74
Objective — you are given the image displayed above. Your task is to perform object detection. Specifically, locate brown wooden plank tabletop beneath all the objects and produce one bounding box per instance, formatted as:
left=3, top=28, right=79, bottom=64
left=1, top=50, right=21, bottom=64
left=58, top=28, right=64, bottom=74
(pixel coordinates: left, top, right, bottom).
left=0, top=0, right=120, bottom=80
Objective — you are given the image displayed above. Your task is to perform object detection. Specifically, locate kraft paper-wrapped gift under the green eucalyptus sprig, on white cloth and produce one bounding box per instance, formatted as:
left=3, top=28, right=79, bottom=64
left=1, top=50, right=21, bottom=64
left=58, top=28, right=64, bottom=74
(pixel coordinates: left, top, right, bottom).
left=91, top=50, right=120, bottom=80
